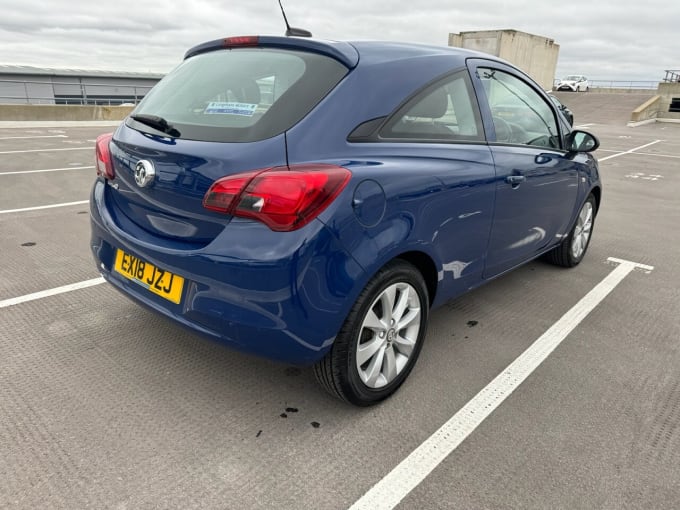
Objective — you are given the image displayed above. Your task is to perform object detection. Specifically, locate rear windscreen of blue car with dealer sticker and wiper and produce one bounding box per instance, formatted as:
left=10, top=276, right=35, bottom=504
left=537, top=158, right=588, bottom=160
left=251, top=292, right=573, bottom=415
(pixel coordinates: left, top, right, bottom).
left=126, top=48, right=348, bottom=142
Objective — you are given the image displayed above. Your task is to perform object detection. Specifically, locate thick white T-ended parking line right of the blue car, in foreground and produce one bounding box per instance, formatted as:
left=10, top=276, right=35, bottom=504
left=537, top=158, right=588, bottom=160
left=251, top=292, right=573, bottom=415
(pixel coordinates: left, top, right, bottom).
left=350, top=258, right=654, bottom=510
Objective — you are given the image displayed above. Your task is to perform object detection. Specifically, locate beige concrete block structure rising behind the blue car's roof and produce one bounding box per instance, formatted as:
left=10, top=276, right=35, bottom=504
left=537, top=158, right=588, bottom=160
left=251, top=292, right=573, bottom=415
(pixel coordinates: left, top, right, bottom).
left=449, top=30, right=560, bottom=90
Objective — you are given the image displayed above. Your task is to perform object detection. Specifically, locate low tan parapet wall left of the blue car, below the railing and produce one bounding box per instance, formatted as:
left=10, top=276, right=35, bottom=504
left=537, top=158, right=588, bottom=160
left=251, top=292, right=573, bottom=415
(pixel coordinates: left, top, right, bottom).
left=0, top=104, right=134, bottom=121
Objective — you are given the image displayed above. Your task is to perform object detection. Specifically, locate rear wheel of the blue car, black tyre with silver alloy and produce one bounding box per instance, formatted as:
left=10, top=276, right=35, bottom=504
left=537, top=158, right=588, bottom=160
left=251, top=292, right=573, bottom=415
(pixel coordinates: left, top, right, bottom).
left=314, top=260, right=430, bottom=406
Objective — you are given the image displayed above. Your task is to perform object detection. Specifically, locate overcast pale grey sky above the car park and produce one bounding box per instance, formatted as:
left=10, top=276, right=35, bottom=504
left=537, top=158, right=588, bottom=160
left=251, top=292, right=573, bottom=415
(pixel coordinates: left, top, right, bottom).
left=0, top=0, right=680, bottom=81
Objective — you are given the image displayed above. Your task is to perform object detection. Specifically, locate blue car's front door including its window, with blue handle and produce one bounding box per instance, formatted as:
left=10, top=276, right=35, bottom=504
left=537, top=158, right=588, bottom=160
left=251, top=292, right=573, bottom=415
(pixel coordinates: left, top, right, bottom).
left=469, top=59, right=578, bottom=278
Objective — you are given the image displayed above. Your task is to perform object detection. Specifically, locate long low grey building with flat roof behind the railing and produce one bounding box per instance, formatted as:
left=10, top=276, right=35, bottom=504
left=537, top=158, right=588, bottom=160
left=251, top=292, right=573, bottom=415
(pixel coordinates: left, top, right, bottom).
left=0, top=65, right=163, bottom=105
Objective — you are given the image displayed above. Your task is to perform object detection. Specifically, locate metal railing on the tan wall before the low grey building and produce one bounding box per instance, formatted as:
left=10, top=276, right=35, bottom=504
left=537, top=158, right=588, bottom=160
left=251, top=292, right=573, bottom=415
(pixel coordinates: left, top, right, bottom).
left=0, top=77, right=155, bottom=105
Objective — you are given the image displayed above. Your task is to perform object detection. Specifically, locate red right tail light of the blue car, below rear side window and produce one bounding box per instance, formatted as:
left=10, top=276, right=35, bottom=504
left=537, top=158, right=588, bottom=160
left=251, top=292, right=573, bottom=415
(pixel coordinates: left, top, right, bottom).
left=203, top=164, right=351, bottom=232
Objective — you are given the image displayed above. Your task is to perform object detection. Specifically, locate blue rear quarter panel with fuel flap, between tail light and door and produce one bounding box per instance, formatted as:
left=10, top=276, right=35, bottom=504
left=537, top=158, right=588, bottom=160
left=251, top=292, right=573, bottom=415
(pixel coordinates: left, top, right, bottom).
left=312, top=144, right=495, bottom=304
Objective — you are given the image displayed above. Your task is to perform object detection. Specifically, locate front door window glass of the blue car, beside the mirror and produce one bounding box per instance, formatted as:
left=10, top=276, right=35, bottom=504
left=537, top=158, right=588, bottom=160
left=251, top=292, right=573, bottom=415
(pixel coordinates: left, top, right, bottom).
left=478, top=67, right=560, bottom=148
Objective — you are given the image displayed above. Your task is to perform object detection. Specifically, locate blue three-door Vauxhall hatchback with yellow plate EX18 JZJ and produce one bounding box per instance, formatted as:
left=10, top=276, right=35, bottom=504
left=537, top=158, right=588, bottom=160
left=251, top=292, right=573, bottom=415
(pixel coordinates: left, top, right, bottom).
left=91, top=36, right=601, bottom=405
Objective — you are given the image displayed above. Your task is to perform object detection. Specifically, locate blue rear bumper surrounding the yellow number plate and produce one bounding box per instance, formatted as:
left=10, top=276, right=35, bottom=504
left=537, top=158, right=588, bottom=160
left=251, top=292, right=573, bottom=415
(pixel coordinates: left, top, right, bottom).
left=90, top=180, right=364, bottom=365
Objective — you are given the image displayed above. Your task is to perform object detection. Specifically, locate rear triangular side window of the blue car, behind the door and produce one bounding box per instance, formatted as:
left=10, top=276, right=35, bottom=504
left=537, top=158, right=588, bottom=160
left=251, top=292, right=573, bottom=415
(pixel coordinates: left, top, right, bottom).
left=379, top=71, right=484, bottom=142
